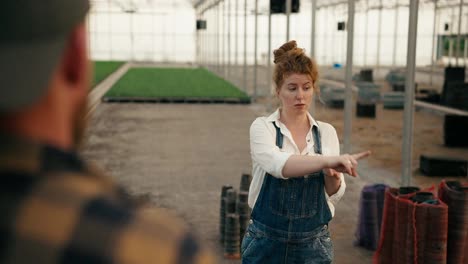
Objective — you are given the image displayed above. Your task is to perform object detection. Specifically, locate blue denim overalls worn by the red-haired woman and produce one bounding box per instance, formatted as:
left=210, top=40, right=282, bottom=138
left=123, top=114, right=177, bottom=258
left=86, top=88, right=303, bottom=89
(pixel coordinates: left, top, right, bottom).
left=241, top=123, right=333, bottom=264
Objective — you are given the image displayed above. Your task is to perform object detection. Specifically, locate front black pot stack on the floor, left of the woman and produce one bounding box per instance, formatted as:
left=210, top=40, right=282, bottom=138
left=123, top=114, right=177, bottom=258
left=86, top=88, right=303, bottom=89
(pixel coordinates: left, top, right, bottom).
left=224, top=189, right=240, bottom=259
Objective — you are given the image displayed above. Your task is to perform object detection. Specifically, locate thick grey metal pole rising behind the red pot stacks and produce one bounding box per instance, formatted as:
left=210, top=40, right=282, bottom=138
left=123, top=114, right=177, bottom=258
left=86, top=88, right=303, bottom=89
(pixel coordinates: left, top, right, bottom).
left=401, top=0, right=419, bottom=186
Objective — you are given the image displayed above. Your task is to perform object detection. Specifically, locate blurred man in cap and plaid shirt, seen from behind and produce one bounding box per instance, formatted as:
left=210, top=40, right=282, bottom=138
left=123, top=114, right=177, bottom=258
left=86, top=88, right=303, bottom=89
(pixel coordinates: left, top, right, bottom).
left=0, top=0, right=213, bottom=263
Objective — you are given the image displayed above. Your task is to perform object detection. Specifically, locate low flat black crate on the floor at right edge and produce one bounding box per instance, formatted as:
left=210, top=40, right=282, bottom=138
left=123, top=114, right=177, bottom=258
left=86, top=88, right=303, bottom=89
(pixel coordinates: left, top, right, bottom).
left=419, top=155, right=468, bottom=176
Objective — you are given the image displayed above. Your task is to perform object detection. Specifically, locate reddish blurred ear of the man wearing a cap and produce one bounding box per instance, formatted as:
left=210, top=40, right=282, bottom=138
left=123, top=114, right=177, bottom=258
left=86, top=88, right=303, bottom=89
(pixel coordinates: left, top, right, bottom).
left=61, top=23, right=89, bottom=85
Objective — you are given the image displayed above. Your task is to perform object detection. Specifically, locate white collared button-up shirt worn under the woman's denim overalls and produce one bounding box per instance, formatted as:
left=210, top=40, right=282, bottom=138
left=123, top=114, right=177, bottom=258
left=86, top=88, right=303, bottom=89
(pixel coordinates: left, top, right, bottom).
left=248, top=109, right=346, bottom=216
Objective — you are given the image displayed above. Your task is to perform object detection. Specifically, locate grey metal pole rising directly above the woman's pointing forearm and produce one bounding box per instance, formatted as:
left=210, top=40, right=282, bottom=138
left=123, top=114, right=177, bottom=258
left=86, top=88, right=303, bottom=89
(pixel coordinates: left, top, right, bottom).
left=344, top=0, right=354, bottom=153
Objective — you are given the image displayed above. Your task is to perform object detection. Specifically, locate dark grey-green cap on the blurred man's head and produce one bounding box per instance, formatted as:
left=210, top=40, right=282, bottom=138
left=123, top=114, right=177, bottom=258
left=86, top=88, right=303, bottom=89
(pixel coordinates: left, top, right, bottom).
left=0, top=0, right=89, bottom=112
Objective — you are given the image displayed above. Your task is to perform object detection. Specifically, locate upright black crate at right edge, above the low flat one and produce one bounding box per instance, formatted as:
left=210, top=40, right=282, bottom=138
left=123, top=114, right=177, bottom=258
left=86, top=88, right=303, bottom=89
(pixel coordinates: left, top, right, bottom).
left=444, top=115, right=468, bottom=147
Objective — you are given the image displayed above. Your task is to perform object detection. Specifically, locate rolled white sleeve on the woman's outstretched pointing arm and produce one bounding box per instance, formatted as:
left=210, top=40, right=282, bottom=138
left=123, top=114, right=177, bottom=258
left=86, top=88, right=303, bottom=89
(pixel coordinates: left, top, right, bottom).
left=250, top=118, right=292, bottom=179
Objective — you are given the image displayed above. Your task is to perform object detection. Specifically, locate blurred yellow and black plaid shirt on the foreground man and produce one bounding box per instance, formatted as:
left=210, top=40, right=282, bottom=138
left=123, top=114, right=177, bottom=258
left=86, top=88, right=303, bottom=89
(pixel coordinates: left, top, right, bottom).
left=0, top=134, right=214, bottom=264
